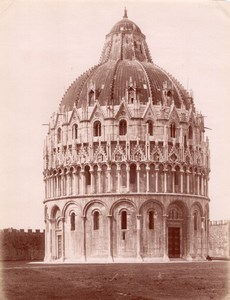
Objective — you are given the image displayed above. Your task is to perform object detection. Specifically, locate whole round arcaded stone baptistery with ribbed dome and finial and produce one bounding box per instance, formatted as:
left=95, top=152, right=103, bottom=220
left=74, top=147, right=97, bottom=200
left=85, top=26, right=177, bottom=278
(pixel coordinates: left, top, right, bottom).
left=44, top=10, right=210, bottom=262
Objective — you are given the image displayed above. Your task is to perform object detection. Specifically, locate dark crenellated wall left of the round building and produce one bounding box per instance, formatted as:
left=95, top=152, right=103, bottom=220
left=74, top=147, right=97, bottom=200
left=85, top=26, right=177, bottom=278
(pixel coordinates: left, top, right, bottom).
left=0, top=228, right=45, bottom=260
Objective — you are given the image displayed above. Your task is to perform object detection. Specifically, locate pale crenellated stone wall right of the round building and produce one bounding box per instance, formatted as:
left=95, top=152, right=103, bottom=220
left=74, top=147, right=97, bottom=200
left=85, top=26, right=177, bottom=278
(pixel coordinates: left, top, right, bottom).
left=209, top=220, right=230, bottom=258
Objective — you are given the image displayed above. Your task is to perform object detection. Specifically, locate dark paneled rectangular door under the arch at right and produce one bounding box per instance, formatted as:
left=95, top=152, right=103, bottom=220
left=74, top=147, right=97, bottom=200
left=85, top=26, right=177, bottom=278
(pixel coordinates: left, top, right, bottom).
left=168, top=227, right=180, bottom=258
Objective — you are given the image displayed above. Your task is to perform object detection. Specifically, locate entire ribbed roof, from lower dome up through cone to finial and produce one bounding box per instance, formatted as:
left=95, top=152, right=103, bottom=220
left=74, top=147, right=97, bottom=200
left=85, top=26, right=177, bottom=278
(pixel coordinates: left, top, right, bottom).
left=61, top=10, right=191, bottom=110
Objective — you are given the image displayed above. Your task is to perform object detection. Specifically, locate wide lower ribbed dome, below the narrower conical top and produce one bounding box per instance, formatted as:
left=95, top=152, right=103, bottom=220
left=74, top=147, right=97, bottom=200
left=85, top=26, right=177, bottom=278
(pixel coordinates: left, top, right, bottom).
left=61, top=59, right=190, bottom=110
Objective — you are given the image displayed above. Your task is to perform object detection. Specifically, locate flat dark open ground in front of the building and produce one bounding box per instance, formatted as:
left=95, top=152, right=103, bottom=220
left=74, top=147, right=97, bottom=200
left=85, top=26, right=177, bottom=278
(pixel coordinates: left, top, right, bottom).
left=0, top=261, right=230, bottom=300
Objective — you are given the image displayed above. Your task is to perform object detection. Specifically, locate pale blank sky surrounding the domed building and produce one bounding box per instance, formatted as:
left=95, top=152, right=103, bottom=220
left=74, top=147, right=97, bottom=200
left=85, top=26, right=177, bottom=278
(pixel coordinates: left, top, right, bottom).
left=0, top=0, right=230, bottom=229
